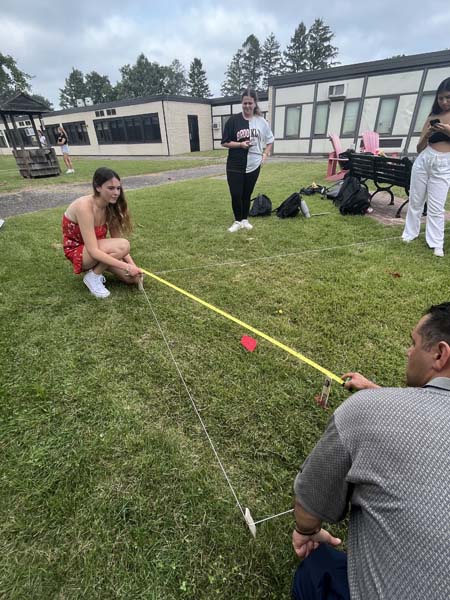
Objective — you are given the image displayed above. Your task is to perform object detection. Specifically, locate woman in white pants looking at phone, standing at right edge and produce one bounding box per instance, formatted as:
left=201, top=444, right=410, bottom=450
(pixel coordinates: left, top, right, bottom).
left=402, top=77, right=450, bottom=256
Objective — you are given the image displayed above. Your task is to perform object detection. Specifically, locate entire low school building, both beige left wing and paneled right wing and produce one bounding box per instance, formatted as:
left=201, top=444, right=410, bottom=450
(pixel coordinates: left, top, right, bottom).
left=0, top=50, right=450, bottom=156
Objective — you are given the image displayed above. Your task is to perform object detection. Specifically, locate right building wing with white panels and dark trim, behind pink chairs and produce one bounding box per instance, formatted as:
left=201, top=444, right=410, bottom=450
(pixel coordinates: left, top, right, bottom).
left=269, top=50, right=450, bottom=156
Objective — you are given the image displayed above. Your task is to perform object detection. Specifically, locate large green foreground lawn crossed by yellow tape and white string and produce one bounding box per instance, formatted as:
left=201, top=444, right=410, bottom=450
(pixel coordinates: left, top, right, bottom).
left=0, top=160, right=450, bottom=600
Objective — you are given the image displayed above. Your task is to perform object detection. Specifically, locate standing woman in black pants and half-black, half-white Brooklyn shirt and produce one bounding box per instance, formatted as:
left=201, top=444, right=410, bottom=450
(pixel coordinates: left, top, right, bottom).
left=222, top=88, right=274, bottom=233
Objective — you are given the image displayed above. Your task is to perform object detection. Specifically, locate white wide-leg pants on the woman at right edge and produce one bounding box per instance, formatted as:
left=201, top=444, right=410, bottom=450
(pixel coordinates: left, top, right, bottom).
left=402, top=146, right=450, bottom=249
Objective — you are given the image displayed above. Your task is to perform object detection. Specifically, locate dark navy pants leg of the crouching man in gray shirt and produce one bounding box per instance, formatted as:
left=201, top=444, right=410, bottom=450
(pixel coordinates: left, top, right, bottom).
left=292, top=544, right=350, bottom=600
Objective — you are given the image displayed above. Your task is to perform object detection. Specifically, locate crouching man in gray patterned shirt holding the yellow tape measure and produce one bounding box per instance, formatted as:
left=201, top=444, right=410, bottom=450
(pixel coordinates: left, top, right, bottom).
left=292, top=302, right=450, bottom=600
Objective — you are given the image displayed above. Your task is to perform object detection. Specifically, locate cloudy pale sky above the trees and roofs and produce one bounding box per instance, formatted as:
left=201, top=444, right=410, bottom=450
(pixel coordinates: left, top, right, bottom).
left=0, top=0, right=450, bottom=109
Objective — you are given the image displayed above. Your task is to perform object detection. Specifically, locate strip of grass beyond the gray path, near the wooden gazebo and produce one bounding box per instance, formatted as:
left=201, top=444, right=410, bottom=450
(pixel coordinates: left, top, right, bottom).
left=0, top=151, right=224, bottom=194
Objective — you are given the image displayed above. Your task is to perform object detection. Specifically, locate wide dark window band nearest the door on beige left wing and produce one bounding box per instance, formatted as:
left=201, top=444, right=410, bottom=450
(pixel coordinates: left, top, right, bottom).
left=94, top=109, right=161, bottom=144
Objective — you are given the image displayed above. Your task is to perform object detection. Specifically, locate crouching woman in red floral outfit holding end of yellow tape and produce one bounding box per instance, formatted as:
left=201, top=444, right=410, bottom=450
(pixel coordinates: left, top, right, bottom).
left=62, top=167, right=142, bottom=298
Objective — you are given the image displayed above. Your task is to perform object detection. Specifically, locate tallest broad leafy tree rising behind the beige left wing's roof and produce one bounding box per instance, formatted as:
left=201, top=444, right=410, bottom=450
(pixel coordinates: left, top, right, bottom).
left=117, top=54, right=167, bottom=99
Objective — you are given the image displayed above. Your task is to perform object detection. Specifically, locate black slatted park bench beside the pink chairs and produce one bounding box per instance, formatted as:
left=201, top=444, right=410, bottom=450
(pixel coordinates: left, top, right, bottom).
left=345, top=152, right=412, bottom=217
